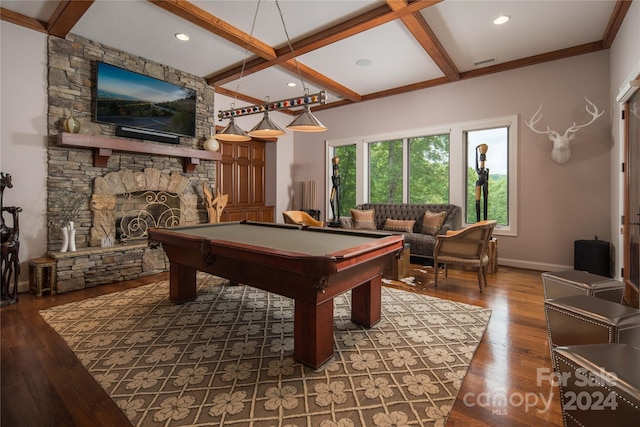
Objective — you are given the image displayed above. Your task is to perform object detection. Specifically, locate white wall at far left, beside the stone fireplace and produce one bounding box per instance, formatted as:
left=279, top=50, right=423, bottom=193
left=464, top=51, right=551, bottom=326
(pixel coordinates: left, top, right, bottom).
left=0, top=21, right=47, bottom=291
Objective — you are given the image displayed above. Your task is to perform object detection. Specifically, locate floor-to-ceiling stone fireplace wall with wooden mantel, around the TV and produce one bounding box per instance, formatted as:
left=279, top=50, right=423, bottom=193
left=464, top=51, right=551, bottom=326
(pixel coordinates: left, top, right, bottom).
left=47, top=34, right=217, bottom=292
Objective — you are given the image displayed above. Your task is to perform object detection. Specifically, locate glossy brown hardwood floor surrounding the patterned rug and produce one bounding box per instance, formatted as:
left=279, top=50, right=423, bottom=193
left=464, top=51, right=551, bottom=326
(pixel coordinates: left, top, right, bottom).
left=0, top=265, right=562, bottom=427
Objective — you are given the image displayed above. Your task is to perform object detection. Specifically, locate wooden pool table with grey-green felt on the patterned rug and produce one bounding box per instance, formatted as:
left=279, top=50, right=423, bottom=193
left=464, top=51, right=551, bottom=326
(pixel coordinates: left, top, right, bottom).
left=149, top=221, right=404, bottom=368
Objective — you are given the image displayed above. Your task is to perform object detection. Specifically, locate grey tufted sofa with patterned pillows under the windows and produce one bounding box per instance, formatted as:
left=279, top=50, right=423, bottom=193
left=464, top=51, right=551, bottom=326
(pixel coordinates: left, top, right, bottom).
left=340, top=203, right=462, bottom=258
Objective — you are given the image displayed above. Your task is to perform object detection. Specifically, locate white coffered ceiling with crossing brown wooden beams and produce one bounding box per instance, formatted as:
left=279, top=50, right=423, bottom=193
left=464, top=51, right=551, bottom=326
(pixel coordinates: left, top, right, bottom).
left=1, top=0, right=631, bottom=113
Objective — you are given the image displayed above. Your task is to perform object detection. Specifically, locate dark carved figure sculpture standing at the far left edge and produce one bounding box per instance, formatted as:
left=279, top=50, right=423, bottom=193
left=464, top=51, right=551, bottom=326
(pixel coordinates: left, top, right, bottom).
left=0, top=172, right=22, bottom=307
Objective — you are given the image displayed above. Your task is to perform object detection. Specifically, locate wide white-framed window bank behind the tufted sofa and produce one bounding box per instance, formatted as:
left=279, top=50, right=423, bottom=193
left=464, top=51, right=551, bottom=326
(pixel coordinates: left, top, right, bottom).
left=326, top=116, right=518, bottom=235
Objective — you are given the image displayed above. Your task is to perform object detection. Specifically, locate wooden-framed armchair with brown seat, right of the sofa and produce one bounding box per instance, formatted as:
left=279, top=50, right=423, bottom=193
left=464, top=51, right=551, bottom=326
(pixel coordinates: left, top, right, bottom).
left=433, top=220, right=496, bottom=293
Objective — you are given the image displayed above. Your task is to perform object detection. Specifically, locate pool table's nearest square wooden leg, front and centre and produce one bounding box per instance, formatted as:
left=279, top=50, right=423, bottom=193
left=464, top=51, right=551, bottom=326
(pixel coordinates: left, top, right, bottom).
left=293, top=299, right=333, bottom=368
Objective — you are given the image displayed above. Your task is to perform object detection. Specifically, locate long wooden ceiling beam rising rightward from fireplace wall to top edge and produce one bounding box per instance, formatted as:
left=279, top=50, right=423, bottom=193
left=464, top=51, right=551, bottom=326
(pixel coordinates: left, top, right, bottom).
left=207, top=0, right=442, bottom=86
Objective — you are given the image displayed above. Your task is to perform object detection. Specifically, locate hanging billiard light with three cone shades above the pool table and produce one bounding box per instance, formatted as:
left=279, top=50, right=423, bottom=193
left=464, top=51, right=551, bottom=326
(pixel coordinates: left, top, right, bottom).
left=215, top=0, right=327, bottom=141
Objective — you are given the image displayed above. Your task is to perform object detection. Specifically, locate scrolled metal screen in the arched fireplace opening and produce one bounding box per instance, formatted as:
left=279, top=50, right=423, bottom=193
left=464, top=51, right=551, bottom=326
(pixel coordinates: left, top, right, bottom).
left=116, top=190, right=186, bottom=242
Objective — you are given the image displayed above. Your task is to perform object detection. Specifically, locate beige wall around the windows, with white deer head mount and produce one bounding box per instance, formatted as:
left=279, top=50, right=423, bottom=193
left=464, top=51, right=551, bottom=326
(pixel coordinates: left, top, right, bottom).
left=294, top=51, right=608, bottom=270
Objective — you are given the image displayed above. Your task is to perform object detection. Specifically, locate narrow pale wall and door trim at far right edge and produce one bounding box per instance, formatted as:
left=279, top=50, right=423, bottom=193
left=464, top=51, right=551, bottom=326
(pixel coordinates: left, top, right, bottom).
left=609, top=1, right=640, bottom=278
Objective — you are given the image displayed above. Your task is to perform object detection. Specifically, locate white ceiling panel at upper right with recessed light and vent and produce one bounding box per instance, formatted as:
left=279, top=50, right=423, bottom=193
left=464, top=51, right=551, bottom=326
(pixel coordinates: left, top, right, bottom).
left=421, top=0, right=615, bottom=71
